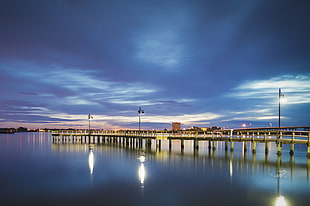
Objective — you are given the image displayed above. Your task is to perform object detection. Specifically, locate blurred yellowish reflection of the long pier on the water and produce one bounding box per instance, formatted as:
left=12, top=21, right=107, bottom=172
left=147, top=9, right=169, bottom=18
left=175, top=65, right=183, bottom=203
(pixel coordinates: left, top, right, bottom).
left=52, top=140, right=310, bottom=182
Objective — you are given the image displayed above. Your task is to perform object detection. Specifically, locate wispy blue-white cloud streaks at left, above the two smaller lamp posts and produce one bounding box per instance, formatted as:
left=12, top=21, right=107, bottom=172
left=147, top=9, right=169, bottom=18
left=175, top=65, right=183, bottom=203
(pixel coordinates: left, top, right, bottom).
left=0, top=62, right=158, bottom=105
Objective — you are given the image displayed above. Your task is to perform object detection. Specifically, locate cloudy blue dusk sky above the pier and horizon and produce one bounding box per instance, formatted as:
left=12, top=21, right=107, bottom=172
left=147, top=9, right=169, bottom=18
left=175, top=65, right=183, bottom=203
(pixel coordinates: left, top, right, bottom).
left=0, top=0, right=310, bottom=129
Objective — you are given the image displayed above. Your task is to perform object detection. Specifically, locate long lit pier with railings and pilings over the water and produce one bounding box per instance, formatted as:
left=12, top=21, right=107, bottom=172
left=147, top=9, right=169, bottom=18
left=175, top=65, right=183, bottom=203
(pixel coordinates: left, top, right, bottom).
left=52, top=127, right=310, bottom=157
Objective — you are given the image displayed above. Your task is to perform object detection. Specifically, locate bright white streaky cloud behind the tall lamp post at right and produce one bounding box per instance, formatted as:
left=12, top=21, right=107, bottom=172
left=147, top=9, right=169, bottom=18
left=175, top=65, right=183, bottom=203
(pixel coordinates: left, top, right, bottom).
left=218, top=74, right=310, bottom=126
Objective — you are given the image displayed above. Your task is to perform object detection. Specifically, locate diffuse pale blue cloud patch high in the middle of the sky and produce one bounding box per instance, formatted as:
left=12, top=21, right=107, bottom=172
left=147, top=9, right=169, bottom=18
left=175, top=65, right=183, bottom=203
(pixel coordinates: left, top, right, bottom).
left=132, top=5, right=193, bottom=72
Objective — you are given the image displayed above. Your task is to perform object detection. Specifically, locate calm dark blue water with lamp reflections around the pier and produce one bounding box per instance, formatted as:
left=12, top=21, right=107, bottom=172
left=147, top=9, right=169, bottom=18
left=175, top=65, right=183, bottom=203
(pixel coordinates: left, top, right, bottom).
left=0, top=133, right=310, bottom=206
